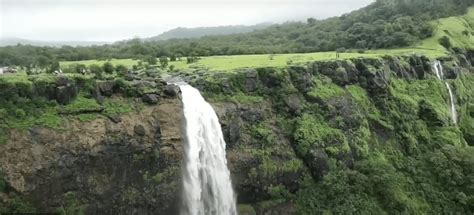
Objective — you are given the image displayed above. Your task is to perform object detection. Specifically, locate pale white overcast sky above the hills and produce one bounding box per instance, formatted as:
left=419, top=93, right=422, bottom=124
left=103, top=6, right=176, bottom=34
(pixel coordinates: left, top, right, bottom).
left=0, top=0, right=374, bottom=41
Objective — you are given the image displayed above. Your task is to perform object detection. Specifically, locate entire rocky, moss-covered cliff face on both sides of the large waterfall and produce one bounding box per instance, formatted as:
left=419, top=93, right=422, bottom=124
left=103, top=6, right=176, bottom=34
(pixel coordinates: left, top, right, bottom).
left=0, top=53, right=474, bottom=214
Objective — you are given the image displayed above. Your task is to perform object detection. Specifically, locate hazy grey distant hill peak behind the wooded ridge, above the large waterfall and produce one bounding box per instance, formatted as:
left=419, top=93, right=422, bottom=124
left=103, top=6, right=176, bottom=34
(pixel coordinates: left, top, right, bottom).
left=145, top=23, right=271, bottom=41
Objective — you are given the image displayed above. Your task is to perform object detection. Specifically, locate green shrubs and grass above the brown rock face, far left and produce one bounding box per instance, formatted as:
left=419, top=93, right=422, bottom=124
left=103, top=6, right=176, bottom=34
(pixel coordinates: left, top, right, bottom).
left=0, top=73, right=139, bottom=144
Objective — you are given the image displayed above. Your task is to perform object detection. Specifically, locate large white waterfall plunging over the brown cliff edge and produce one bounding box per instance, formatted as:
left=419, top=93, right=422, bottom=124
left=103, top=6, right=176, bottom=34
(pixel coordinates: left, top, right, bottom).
left=180, top=84, right=237, bottom=215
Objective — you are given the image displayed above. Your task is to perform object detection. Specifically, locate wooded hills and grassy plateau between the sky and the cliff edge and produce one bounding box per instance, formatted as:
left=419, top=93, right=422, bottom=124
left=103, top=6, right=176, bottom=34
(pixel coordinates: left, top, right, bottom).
left=0, top=0, right=474, bottom=72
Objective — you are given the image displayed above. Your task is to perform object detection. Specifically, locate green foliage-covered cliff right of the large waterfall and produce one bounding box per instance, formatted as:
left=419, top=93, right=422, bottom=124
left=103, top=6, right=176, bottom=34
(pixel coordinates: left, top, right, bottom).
left=195, top=52, right=474, bottom=214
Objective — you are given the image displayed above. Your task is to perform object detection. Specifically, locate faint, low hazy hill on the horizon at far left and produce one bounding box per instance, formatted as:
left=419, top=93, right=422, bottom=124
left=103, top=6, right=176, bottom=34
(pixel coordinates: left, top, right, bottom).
left=0, top=37, right=109, bottom=47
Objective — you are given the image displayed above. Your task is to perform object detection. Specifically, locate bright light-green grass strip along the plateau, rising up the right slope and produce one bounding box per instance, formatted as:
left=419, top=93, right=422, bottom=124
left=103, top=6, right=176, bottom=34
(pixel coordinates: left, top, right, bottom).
left=61, top=7, right=474, bottom=71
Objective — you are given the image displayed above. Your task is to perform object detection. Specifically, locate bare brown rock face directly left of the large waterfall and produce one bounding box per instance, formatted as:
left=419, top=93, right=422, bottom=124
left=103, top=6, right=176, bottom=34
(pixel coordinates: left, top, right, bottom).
left=0, top=99, right=182, bottom=214
